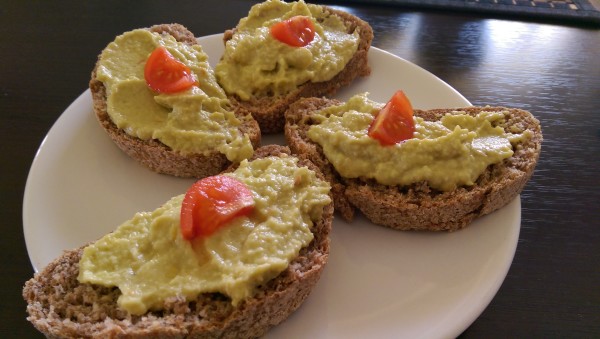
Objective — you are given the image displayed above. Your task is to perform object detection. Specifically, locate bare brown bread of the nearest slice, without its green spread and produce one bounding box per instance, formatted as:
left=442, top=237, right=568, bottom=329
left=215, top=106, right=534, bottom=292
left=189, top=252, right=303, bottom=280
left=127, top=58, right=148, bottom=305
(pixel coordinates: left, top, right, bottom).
left=23, top=146, right=333, bottom=338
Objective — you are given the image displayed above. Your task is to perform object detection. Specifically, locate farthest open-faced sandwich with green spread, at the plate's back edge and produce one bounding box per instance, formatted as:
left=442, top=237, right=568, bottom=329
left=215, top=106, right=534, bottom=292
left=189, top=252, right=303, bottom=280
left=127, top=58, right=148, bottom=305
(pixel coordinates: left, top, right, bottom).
left=215, top=0, right=373, bottom=133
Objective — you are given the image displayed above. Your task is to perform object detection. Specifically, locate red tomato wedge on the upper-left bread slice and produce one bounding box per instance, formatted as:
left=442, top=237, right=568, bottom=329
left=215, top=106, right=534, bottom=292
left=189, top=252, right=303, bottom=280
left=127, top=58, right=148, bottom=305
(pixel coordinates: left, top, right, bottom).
left=144, top=46, right=198, bottom=93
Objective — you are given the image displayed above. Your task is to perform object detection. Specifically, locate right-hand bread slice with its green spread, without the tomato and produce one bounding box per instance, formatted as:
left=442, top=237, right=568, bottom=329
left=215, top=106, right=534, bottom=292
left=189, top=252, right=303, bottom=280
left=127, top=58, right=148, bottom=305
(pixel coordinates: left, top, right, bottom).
left=285, top=95, right=542, bottom=231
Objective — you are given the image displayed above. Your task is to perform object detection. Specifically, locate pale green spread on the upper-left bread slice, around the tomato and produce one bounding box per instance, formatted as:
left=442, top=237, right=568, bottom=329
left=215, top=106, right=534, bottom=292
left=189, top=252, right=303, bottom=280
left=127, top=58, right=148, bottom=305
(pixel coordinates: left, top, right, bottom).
left=96, top=29, right=253, bottom=161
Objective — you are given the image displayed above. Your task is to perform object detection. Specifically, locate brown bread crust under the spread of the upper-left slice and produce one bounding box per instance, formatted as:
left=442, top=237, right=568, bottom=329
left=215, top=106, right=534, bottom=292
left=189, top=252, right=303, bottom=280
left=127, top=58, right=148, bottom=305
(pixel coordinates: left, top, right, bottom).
left=89, top=24, right=261, bottom=178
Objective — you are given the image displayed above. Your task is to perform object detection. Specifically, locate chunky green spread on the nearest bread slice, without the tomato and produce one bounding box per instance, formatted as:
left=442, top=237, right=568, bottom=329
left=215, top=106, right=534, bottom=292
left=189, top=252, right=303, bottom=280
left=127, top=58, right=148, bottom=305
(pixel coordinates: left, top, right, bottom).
left=78, top=157, right=330, bottom=315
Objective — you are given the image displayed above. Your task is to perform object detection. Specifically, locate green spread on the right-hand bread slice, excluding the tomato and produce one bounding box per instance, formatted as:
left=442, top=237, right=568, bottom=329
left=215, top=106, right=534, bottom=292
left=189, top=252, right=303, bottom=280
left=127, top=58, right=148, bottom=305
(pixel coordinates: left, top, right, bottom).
left=308, top=93, right=529, bottom=191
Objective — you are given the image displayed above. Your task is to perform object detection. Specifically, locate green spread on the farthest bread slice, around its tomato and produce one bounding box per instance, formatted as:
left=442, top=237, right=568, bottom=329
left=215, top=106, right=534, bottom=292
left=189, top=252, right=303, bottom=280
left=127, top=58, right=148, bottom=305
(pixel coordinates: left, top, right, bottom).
left=215, top=0, right=359, bottom=100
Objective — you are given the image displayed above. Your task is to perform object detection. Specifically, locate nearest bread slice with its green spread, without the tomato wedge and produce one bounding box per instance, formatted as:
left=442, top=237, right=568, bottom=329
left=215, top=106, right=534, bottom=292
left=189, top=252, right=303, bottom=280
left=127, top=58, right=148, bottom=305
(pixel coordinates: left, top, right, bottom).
left=23, top=145, right=333, bottom=338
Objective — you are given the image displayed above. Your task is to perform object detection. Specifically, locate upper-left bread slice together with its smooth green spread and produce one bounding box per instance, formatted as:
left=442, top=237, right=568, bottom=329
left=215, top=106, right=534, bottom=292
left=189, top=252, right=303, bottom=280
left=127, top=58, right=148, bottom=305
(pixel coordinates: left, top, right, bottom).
left=89, top=24, right=261, bottom=178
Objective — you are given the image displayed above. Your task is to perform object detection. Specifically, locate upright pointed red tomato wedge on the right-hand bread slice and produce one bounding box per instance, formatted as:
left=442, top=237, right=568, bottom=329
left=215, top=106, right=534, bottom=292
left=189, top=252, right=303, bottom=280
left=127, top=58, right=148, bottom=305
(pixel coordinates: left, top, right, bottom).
left=368, top=91, right=415, bottom=146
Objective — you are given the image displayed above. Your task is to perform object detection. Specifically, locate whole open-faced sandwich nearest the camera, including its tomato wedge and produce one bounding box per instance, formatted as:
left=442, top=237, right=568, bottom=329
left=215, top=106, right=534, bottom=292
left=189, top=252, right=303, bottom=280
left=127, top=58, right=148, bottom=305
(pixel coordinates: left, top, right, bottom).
left=23, top=146, right=333, bottom=338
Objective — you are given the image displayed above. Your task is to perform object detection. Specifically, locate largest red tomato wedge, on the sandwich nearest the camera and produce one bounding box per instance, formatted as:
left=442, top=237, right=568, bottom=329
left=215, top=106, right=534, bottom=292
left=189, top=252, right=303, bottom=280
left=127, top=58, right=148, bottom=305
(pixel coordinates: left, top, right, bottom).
left=180, top=175, right=254, bottom=240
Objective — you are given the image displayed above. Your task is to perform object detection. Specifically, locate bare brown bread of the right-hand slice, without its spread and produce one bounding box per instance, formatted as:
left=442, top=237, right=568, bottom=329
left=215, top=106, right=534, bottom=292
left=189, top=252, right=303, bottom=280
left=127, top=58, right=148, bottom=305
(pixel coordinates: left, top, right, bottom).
left=285, top=98, right=542, bottom=231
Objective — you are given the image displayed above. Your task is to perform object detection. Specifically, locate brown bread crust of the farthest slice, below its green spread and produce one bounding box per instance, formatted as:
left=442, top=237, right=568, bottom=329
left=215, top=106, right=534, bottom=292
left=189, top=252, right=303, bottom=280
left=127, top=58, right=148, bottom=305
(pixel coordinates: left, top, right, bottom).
left=223, top=6, right=373, bottom=133
